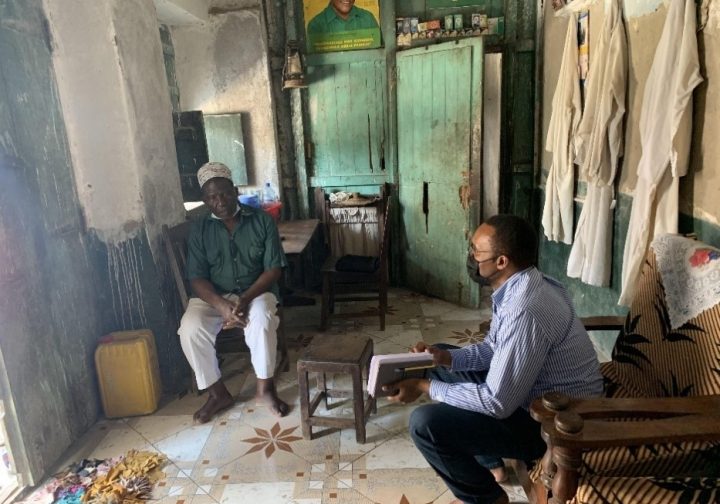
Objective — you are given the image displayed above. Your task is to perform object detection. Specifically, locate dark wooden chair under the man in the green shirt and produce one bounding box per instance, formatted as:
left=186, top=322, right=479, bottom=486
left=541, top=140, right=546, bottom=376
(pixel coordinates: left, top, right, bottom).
left=162, top=221, right=290, bottom=394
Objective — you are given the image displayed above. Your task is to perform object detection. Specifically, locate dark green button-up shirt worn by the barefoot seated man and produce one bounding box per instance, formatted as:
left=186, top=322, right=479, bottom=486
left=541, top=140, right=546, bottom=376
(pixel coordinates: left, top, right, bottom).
left=187, top=205, right=287, bottom=299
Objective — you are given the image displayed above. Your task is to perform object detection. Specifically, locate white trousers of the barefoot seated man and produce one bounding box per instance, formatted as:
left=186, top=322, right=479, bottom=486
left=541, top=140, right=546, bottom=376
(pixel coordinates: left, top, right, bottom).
left=178, top=292, right=280, bottom=390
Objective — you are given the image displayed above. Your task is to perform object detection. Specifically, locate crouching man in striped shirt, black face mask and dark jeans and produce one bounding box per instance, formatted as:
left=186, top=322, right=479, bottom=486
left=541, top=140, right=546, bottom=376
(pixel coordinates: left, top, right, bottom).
left=389, top=215, right=602, bottom=504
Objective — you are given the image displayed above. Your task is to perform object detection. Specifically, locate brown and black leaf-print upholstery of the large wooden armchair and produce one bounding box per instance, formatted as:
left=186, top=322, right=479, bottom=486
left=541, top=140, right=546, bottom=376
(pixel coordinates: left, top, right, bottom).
left=530, top=247, right=720, bottom=504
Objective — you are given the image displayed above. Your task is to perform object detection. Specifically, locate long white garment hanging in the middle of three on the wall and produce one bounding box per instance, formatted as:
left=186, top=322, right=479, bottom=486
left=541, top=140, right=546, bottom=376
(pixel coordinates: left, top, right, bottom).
left=567, top=0, right=627, bottom=287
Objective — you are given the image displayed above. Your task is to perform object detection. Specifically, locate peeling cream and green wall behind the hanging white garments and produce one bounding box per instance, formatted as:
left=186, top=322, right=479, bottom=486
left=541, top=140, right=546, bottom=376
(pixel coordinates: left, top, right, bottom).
left=540, top=0, right=720, bottom=328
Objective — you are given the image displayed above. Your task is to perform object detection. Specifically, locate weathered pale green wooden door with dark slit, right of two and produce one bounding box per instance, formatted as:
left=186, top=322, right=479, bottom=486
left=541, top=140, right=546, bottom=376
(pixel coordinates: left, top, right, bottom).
left=397, top=38, right=483, bottom=306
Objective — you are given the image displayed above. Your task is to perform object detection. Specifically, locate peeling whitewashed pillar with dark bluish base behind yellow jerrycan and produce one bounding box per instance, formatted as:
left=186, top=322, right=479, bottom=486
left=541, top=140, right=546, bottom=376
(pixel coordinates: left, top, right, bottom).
left=45, top=0, right=191, bottom=390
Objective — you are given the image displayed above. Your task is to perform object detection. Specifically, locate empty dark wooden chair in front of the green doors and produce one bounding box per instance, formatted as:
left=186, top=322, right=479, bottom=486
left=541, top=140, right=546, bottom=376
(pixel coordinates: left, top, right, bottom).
left=315, top=185, right=391, bottom=331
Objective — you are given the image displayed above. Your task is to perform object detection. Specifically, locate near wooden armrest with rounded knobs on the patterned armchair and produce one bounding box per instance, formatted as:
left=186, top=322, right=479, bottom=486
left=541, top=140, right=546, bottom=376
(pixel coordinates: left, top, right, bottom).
left=531, top=395, right=720, bottom=450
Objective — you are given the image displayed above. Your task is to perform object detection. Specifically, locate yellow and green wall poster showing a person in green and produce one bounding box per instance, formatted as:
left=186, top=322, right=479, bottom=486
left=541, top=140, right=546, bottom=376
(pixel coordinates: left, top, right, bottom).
left=303, top=0, right=381, bottom=53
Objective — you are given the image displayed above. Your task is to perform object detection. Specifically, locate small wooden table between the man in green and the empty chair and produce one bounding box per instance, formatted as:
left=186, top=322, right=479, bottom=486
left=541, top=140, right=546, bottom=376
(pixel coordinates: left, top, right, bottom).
left=278, top=219, right=320, bottom=305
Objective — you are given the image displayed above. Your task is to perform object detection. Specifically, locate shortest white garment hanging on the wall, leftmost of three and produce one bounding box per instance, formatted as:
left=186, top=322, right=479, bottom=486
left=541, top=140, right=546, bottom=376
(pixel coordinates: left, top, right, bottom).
left=542, top=12, right=582, bottom=243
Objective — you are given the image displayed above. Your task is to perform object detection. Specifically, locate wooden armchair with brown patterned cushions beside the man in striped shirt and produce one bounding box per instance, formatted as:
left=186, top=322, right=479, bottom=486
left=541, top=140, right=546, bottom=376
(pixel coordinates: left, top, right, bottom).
left=531, top=236, right=720, bottom=504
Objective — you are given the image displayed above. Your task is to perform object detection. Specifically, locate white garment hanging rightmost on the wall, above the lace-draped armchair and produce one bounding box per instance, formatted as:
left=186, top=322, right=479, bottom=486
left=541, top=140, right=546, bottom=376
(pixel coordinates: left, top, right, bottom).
left=618, top=0, right=702, bottom=306
